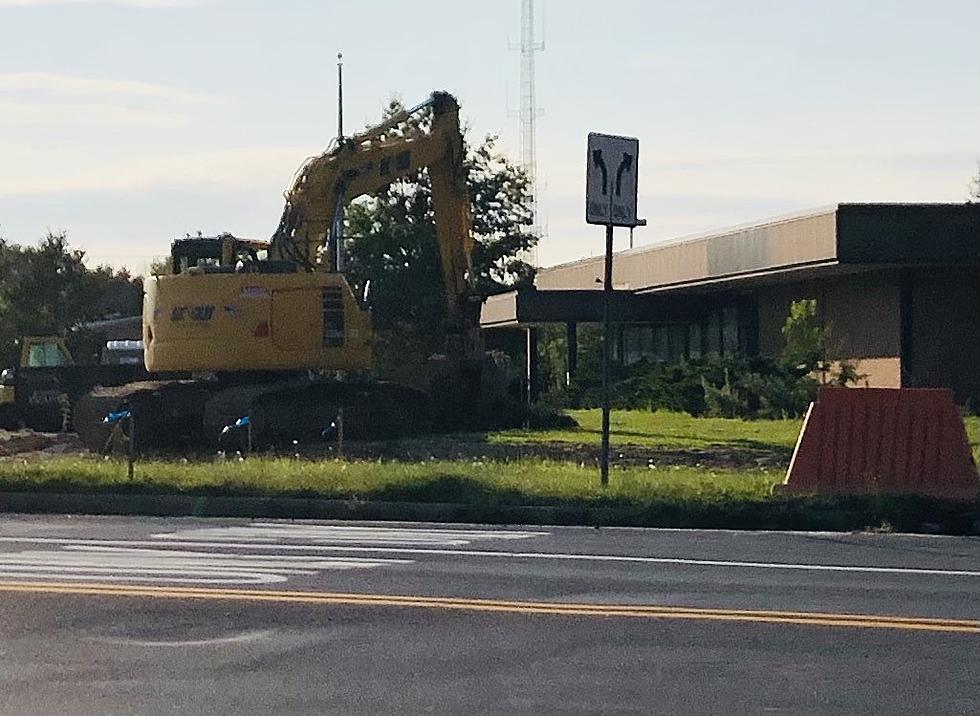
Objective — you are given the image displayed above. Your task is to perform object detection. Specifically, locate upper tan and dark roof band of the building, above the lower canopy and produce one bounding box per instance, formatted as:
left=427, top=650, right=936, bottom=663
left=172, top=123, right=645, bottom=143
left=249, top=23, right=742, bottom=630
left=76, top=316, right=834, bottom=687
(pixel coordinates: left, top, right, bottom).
left=535, top=204, right=980, bottom=293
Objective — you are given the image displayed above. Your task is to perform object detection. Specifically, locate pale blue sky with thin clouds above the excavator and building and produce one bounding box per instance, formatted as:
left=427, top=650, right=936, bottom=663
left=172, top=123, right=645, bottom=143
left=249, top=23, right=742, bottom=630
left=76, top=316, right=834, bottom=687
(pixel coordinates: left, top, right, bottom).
left=0, top=0, right=980, bottom=272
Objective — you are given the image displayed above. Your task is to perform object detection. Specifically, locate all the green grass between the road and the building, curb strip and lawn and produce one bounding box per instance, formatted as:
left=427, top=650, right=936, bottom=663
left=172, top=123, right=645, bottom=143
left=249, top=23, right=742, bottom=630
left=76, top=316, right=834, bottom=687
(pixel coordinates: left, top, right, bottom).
left=0, top=410, right=980, bottom=533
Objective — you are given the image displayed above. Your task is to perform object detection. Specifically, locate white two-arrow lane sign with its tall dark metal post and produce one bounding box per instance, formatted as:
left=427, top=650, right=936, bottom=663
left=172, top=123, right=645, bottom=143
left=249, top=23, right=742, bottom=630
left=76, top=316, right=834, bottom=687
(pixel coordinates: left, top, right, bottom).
left=585, top=132, right=640, bottom=487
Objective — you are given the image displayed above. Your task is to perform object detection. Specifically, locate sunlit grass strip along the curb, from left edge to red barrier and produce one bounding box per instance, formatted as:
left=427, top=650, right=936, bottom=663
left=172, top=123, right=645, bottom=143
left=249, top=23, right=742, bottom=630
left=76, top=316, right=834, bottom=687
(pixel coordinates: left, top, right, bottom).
left=0, top=457, right=780, bottom=506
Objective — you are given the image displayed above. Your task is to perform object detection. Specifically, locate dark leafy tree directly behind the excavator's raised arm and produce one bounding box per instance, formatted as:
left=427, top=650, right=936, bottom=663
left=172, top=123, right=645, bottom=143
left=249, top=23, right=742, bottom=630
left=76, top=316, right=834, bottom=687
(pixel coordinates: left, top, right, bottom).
left=346, top=101, right=537, bottom=332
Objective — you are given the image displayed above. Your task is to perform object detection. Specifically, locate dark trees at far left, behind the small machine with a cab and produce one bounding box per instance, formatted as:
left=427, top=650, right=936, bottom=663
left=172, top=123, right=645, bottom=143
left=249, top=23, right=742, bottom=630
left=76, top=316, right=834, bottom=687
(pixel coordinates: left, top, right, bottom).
left=0, top=232, right=142, bottom=367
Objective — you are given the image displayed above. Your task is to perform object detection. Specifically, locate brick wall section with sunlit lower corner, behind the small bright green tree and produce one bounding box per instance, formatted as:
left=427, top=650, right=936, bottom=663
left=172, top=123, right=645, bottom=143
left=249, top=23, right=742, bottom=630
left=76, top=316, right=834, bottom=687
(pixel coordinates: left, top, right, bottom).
left=757, top=269, right=902, bottom=388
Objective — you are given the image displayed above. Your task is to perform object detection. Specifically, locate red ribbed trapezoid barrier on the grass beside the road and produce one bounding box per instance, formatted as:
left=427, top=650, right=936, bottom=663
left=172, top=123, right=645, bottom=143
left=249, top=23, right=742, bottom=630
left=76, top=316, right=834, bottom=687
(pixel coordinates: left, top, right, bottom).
left=780, top=387, right=980, bottom=500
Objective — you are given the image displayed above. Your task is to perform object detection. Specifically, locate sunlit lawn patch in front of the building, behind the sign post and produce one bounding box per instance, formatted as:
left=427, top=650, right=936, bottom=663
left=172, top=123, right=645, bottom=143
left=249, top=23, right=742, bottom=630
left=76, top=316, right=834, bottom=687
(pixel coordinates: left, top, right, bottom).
left=487, top=410, right=802, bottom=449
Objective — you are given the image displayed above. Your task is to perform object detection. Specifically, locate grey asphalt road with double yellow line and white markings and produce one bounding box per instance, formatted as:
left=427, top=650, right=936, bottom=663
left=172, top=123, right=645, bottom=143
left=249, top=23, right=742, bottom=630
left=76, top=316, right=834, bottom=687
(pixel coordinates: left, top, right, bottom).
left=0, top=515, right=980, bottom=716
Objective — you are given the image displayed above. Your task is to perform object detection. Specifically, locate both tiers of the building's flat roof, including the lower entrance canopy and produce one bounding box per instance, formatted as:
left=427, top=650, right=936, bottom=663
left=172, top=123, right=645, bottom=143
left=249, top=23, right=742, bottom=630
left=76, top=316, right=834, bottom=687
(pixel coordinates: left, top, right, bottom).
left=481, top=203, right=980, bottom=327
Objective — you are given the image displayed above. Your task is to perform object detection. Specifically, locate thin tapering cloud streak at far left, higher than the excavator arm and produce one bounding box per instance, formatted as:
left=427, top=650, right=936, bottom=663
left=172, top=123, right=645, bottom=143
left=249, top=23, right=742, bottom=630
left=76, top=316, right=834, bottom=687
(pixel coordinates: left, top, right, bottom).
left=0, top=72, right=222, bottom=104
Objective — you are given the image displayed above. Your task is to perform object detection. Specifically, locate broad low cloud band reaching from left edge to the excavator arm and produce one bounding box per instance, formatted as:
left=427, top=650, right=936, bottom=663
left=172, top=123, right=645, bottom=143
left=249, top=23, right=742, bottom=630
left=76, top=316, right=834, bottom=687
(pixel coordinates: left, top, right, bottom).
left=0, top=147, right=309, bottom=197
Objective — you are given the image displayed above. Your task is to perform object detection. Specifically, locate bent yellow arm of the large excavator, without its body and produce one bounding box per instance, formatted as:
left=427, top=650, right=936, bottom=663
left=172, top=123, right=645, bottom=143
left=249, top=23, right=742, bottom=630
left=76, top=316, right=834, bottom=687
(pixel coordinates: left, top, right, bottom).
left=272, top=92, right=473, bottom=326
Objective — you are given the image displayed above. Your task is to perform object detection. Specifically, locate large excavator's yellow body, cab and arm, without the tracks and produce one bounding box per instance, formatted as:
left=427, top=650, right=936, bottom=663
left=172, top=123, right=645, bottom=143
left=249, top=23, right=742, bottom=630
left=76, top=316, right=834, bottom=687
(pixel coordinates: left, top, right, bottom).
left=143, top=92, right=476, bottom=373
